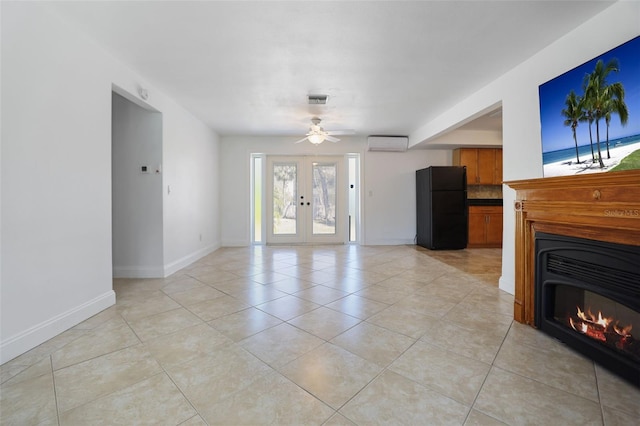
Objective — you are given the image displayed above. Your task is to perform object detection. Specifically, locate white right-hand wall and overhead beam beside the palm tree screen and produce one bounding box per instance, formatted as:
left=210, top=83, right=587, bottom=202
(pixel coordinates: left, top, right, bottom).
left=410, top=1, right=640, bottom=293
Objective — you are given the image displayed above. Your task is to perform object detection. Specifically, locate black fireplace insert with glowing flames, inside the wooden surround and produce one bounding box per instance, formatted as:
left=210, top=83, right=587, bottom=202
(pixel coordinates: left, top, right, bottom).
left=534, top=232, right=640, bottom=386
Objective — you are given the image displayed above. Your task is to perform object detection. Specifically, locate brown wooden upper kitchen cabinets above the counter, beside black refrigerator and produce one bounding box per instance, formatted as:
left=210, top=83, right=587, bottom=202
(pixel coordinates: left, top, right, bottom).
left=453, top=148, right=502, bottom=185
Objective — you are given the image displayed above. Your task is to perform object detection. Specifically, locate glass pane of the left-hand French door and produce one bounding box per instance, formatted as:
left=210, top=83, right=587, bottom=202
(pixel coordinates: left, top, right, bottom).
left=273, top=163, right=298, bottom=235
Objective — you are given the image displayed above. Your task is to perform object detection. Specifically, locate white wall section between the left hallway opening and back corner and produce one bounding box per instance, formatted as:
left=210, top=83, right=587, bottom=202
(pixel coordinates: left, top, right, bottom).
left=160, top=91, right=223, bottom=276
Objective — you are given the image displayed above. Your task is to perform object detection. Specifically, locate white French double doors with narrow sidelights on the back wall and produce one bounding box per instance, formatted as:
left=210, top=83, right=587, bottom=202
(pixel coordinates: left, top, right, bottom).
left=251, top=154, right=360, bottom=244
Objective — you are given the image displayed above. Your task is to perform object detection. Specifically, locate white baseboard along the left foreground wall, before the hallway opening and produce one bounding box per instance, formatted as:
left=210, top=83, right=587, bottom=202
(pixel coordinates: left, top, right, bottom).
left=0, top=290, right=116, bottom=364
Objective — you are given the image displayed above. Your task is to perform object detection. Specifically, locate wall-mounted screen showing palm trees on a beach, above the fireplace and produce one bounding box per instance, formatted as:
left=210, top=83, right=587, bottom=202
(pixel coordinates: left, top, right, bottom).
left=538, top=36, right=640, bottom=177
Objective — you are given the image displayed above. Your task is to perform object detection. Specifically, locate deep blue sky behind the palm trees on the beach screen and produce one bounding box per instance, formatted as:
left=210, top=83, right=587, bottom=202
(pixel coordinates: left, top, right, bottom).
left=539, top=37, right=640, bottom=152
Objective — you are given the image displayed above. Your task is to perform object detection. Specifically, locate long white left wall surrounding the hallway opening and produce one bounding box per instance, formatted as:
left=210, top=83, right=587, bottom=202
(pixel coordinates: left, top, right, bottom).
left=0, top=2, right=220, bottom=362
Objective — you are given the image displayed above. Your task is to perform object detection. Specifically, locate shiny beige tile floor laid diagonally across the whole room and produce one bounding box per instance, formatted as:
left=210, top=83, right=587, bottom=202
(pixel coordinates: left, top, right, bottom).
left=0, top=246, right=640, bottom=425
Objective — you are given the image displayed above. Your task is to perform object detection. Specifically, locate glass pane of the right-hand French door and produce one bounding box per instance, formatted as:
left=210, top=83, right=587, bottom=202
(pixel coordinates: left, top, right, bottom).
left=313, top=163, right=337, bottom=235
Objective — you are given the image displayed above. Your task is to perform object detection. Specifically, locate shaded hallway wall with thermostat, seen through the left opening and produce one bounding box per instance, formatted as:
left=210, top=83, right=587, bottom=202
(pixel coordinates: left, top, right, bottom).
left=111, top=93, right=164, bottom=278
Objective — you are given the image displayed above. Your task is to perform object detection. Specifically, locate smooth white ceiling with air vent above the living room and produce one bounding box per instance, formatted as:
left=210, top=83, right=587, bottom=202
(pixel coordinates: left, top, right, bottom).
left=48, top=0, right=612, bottom=140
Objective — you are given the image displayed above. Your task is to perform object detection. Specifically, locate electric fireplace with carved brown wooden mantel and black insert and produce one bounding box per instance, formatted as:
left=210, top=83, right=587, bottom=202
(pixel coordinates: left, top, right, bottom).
left=505, top=170, right=640, bottom=387
